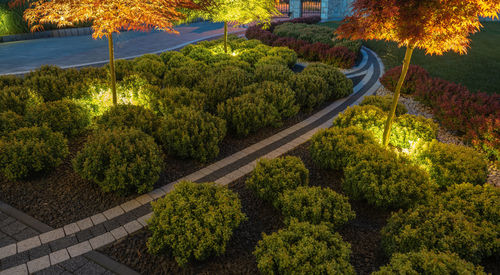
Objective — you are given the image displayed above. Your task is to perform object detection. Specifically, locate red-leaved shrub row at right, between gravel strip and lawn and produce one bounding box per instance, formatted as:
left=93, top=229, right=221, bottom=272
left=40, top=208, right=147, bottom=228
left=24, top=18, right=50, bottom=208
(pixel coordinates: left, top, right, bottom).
left=381, top=65, right=500, bottom=163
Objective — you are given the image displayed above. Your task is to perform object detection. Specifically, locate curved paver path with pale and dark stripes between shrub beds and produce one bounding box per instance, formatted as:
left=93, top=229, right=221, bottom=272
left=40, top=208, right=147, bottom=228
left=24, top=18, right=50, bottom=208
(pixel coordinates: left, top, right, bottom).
left=0, top=48, right=384, bottom=275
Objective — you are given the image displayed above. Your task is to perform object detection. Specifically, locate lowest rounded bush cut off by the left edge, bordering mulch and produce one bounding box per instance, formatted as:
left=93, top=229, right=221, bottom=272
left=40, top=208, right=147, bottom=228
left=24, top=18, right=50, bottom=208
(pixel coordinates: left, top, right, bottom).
left=0, top=126, right=69, bottom=180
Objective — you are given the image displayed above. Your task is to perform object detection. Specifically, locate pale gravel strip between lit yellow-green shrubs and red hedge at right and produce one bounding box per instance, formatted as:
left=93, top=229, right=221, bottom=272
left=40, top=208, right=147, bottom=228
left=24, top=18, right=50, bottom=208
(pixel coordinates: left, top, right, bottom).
left=376, top=86, right=500, bottom=187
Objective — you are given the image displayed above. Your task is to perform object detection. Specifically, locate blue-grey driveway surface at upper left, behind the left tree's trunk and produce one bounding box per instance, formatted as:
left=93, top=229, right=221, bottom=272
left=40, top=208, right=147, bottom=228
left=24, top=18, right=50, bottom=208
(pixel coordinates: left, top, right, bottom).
left=0, top=22, right=244, bottom=75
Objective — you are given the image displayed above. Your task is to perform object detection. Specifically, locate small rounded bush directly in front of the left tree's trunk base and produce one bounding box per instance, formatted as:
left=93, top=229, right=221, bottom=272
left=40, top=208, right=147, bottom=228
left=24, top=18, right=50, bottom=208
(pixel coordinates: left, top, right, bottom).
left=96, top=104, right=160, bottom=136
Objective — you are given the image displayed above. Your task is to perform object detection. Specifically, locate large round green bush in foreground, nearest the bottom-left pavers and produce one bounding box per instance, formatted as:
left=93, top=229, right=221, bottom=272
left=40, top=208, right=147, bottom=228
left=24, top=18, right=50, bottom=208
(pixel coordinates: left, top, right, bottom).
left=147, top=181, right=246, bottom=266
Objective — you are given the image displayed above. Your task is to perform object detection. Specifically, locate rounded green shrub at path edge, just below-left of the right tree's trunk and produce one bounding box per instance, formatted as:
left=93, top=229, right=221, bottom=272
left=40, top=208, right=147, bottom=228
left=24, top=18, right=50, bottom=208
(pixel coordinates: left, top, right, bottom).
left=309, top=127, right=377, bottom=170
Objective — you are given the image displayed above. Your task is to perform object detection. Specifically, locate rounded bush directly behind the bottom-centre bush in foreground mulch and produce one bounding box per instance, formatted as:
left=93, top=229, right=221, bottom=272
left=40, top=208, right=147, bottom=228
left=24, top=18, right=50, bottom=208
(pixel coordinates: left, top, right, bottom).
left=277, top=186, right=356, bottom=229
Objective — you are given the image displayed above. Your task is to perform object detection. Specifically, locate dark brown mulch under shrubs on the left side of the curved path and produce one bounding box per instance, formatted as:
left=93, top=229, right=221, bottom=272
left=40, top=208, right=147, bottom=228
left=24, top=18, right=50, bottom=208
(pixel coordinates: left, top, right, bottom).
left=0, top=99, right=330, bottom=227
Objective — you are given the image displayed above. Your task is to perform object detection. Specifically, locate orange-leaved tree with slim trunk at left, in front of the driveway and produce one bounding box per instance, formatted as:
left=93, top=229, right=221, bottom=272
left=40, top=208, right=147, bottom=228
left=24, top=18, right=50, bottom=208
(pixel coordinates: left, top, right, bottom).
left=22, top=0, right=208, bottom=105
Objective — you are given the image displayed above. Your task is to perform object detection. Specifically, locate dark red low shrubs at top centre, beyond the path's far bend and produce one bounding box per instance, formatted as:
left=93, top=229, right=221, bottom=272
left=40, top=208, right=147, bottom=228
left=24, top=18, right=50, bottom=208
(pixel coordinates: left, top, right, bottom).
left=246, top=17, right=361, bottom=68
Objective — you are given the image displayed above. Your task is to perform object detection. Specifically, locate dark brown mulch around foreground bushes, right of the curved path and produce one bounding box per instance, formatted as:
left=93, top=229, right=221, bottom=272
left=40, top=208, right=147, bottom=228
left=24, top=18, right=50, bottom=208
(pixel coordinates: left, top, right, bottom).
left=103, top=144, right=389, bottom=274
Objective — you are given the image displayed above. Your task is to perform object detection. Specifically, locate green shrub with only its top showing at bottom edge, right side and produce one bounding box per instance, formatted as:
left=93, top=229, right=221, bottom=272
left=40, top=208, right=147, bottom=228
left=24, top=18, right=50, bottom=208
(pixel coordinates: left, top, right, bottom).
left=372, top=250, right=486, bottom=275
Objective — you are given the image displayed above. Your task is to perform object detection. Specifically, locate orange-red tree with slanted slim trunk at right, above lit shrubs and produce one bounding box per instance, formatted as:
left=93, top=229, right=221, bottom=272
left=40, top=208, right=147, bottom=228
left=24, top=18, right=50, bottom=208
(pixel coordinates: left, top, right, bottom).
left=336, top=0, right=500, bottom=146
